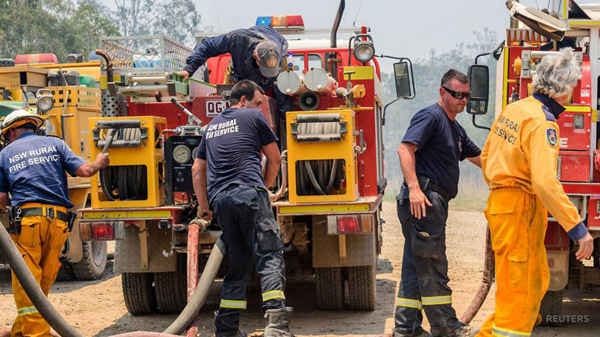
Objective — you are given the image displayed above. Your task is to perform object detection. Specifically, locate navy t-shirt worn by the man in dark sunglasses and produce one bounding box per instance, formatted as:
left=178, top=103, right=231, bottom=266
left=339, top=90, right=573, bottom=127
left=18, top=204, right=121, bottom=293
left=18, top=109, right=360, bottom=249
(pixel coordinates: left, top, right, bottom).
left=402, top=103, right=481, bottom=198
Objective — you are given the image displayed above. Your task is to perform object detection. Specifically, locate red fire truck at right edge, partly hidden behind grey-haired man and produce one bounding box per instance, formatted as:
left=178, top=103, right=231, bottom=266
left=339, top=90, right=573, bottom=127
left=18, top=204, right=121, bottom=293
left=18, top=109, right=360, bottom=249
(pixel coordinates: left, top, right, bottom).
left=467, top=1, right=600, bottom=323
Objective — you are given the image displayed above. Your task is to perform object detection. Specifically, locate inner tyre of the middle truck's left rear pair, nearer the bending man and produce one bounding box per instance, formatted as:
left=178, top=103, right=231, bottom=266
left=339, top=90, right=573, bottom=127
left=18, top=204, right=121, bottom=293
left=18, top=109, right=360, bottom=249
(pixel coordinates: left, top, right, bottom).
left=154, top=272, right=187, bottom=314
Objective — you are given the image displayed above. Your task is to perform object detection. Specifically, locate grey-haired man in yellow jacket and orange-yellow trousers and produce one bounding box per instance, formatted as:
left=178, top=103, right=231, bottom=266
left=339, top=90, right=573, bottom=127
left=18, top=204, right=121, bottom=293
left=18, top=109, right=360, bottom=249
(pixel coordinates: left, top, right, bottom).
left=477, top=51, right=593, bottom=337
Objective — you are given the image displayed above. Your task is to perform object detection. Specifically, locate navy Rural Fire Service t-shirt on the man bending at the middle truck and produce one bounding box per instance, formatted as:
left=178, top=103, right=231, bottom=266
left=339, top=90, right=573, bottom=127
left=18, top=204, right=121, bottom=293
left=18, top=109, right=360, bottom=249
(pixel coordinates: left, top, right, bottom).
left=197, top=108, right=277, bottom=202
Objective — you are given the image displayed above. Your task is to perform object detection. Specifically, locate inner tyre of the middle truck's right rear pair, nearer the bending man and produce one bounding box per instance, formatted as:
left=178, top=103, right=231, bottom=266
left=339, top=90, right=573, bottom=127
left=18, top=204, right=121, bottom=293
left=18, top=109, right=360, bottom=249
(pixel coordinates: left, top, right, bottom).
left=315, top=268, right=344, bottom=310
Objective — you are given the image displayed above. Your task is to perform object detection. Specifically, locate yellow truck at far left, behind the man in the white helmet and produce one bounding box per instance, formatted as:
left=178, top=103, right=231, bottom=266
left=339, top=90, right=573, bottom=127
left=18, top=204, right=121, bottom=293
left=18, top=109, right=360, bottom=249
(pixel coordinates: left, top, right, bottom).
left=0, top=53, right=107, bottom=280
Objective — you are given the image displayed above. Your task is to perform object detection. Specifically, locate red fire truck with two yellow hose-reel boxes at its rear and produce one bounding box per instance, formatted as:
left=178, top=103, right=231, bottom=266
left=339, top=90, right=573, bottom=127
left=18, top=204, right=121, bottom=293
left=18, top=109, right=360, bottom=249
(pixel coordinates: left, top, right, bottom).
left=81, top=1, right=414, bottom=315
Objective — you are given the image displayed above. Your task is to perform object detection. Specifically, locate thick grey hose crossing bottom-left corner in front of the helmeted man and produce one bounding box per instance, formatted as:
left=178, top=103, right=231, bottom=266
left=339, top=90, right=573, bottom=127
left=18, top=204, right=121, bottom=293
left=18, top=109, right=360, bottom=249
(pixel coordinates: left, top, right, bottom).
left=0, top=224, right=83, bottom=337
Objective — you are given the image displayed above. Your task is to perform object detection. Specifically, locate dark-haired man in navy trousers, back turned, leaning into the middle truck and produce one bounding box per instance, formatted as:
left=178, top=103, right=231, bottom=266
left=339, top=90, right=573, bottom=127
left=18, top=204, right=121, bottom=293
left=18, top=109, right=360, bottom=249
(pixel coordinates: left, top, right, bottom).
left=192, top=80, right=291, bottom=337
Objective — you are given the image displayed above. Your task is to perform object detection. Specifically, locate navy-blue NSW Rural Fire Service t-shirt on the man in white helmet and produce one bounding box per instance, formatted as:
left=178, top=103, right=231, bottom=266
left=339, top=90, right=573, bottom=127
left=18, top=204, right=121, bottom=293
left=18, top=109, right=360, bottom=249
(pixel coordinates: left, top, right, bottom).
left=0, top=133, right=85, bottom=208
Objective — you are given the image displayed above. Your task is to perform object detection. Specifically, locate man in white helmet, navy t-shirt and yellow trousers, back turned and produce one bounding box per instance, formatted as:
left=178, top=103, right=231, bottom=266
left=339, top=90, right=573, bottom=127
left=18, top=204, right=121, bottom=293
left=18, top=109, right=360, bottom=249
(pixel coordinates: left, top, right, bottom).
left=0, top=110, right=109, bottom=337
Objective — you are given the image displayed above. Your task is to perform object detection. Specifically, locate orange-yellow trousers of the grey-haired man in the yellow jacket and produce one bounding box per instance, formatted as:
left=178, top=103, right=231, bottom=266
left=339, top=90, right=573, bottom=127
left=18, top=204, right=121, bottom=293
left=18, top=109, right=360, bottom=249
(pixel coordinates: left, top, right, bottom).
left=477, top=188, right=550, bottom=337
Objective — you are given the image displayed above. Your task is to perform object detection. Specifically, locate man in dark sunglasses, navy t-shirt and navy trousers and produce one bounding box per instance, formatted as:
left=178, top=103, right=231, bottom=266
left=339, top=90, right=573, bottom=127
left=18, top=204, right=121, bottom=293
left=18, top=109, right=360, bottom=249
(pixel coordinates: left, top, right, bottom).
left=393, top=69, right=481, bottom=337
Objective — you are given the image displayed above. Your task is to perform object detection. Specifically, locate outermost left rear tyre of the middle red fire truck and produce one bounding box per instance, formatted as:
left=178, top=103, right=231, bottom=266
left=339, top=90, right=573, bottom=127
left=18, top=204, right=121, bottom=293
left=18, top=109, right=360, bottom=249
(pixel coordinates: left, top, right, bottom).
left=121, top=273, right=156, bottom=316
